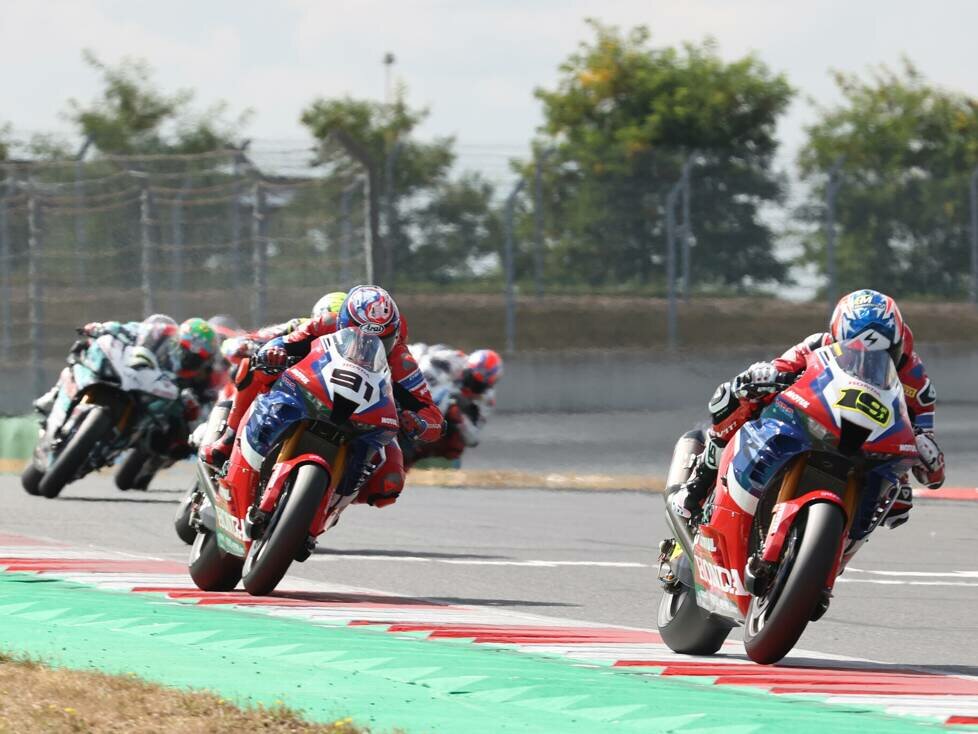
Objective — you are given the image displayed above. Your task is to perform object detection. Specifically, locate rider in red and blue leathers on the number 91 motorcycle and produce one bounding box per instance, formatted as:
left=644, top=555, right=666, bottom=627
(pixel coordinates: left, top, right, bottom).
left=200, top=285, right=443, bottom=507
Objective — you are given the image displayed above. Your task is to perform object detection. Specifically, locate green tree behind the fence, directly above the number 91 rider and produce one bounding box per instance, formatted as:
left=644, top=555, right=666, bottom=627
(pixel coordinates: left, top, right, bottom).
left=301, top=90, right=497, bottom=284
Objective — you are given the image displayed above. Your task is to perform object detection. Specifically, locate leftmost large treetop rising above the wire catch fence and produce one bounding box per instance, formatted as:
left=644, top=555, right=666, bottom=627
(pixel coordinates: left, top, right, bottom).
left=66, top=51, right=249, bottom=154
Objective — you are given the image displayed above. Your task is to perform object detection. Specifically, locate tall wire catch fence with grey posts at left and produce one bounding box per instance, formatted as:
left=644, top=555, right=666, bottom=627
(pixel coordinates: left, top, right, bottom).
left=0, top=150, right=372, bottom=412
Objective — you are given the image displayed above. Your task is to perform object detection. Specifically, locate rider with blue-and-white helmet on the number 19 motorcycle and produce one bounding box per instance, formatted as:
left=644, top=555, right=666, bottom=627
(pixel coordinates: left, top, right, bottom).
left=669, top=289, right=944, bottom=528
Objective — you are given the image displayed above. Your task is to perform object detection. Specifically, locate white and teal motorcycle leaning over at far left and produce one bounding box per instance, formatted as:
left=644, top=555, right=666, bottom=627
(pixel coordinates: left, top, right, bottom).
left=21, top=334, right=180, bottom=498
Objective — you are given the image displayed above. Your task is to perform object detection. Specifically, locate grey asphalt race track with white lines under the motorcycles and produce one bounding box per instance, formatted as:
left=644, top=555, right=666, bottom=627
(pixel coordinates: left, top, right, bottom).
left=0, top=410, right=978, bottom=675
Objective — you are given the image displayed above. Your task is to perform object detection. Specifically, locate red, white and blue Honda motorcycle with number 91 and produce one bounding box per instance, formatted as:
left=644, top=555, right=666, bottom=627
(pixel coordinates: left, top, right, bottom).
left=189, top=328, right=398, bottom=595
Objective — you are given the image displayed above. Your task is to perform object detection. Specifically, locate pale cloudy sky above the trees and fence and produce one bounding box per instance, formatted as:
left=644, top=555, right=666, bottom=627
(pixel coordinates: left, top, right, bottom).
left=0, top=0, right=978, bottom=190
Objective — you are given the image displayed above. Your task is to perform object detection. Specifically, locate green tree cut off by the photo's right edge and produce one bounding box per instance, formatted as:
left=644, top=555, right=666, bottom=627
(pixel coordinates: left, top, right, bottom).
left=799, top=60, right=978, bottom=297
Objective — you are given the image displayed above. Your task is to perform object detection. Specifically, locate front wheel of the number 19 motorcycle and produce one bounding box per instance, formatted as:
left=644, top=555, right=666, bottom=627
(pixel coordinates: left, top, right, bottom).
left=744, top=502, right=846, bottom=665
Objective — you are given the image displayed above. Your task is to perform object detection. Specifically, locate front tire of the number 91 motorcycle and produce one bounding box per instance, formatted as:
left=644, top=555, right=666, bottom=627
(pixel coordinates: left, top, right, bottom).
left=244, top=464, right=329, bottom=596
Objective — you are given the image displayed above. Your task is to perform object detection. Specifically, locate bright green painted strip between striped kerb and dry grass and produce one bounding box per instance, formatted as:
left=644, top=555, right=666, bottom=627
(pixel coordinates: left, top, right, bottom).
left=0, top=574, right=960, bottom=734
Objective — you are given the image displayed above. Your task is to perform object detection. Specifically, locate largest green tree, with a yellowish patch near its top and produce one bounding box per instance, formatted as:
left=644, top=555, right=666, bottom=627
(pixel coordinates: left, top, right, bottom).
left=525, top=20, right=792, bottom=285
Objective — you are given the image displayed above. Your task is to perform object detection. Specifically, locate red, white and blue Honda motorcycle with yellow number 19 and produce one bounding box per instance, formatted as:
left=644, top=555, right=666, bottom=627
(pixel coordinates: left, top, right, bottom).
left=658, top=340, right=917, bottom=664
